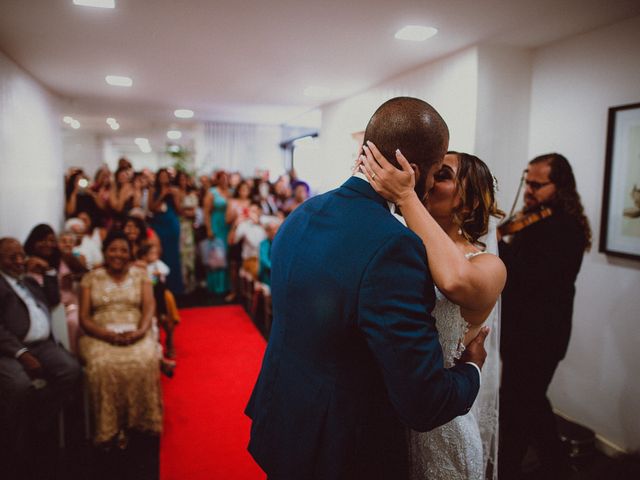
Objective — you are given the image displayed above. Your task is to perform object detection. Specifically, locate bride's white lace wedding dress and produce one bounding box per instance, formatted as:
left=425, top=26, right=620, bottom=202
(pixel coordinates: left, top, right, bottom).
left=409, top=252, right=500, bottom=480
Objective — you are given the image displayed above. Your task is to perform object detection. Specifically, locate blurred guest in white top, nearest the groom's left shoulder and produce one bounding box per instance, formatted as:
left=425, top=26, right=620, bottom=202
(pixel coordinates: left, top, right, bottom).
left=229, top=203, right=267, bottom=280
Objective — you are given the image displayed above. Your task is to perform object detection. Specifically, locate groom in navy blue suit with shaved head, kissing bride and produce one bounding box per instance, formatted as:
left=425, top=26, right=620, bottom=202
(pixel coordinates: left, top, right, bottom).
left=247, top=97, right=485, bottom=480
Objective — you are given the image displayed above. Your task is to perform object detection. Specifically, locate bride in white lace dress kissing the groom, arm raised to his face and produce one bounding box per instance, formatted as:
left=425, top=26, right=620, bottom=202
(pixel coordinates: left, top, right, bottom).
left=360, top=142, right=506, bottom=480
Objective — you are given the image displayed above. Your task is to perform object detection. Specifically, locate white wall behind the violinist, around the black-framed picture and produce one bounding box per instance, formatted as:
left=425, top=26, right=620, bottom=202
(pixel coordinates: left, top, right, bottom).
left=529, top=17, right=640, bottom=450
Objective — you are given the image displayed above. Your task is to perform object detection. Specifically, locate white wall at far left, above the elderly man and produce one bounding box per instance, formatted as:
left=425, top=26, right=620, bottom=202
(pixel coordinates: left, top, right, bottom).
left=0, top=52, right=64, bottom=241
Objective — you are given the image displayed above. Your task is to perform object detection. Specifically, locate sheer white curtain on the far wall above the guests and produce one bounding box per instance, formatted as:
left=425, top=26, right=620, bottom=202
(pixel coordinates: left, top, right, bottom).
left=198, top=122, right=284, bottom=178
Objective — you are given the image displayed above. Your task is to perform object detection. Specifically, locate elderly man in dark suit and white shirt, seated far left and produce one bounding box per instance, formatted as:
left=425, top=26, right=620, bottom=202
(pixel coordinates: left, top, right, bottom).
left=0, top=238, right=80, bottom=478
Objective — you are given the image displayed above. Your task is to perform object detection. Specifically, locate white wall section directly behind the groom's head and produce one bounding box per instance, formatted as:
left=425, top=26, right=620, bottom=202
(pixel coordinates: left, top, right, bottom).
left=318, top=48, right=477, bottom=191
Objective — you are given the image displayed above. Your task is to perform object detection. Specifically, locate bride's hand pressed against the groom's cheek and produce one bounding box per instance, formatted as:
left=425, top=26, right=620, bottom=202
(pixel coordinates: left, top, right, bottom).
left=360, top=142, right=416, bottom=204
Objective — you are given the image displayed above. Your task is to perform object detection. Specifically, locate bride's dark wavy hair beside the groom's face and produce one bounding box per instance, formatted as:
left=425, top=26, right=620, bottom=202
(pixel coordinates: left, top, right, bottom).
left=447, top=152, right=505, bottom=248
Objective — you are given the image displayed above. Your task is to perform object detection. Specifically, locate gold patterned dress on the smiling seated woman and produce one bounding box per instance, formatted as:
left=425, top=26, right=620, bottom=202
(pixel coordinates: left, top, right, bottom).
left=79, top=267, right=162, bottom=444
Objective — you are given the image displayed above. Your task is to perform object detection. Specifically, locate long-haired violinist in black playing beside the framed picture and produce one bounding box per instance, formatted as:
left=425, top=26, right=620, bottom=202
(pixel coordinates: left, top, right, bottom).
left=498, top=153, right=591, bottom=479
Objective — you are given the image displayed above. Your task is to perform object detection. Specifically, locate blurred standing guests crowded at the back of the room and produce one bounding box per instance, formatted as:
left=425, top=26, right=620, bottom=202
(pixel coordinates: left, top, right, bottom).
left=65, top=158, right=310, bottom=301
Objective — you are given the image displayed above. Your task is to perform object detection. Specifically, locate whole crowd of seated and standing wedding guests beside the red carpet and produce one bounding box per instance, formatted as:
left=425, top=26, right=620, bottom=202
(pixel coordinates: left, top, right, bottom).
left=0, top=158, right=309, bottom=478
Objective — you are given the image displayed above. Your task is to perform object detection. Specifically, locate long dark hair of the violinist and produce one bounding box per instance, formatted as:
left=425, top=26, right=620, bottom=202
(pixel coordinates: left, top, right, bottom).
left=529, top=153, right=591, bottom=251
